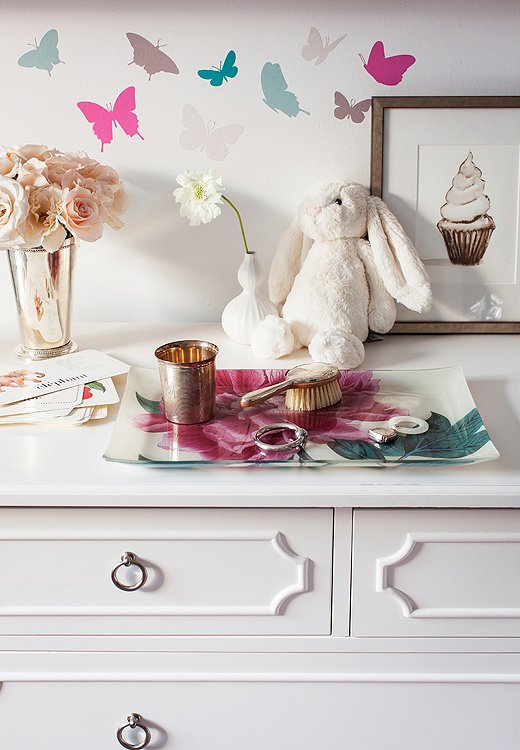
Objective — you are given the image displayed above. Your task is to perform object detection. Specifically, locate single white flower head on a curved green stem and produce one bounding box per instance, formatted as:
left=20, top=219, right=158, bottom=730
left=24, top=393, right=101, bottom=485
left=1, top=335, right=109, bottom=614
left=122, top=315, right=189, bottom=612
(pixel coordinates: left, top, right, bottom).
left=173, top=169, right=224, bottom=227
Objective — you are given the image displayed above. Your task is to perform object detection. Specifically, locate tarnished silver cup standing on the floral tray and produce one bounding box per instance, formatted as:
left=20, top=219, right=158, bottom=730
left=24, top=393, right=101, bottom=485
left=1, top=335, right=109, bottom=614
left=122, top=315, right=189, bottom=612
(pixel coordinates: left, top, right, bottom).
left=155, top=340, right=218, bottom=424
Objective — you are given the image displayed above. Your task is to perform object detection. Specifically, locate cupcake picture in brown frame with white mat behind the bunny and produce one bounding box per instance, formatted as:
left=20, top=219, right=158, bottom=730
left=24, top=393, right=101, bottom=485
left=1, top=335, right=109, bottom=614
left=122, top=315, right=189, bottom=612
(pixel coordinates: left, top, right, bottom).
left=370, top=96, right=520, bottom=333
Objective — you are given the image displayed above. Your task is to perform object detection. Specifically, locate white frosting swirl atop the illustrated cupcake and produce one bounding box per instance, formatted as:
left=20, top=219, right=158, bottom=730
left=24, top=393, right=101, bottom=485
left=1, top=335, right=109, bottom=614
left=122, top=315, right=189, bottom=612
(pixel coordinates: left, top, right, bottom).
left=441, top=151, right=490, bottom=223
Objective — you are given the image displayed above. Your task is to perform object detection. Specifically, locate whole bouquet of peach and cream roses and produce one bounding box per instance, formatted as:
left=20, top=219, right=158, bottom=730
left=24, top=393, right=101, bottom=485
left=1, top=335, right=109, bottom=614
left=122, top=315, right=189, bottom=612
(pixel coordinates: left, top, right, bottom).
left=0, top=144, right=128, bottom=252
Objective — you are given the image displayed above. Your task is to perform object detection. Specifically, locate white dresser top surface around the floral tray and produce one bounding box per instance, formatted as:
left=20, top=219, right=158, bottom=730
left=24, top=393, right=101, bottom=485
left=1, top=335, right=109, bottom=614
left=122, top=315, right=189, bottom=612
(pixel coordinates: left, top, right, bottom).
left=0, top=323, right=520, bottom=507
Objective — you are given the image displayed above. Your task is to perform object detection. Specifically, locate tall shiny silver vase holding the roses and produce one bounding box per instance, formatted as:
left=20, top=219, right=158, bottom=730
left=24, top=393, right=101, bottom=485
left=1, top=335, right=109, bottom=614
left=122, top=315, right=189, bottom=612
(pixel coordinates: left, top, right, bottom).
left=7, top=237, right=77, bottom=361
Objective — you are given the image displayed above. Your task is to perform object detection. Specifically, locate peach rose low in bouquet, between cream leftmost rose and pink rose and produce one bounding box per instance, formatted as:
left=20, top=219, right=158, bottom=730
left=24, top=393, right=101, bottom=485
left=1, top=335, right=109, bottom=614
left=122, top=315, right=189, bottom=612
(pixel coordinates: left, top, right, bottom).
left=22, top=185, right=67, bottom=252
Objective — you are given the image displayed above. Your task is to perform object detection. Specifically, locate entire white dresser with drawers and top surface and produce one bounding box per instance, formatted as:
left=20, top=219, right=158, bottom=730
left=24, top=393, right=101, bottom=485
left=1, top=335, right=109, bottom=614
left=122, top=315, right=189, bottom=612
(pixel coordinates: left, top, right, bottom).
left=0, top=324, right=520, bottom=750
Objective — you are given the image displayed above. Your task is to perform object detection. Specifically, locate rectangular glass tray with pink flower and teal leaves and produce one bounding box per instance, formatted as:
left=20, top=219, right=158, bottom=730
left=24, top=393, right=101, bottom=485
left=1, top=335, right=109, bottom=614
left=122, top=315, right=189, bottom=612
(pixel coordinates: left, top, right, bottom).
left=104, top=367, right=499, bottom=466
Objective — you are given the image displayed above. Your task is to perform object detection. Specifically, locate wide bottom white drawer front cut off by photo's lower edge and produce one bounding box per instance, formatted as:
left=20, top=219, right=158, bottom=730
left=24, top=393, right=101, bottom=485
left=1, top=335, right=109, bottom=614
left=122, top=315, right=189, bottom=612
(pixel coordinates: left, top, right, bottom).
left=0, top=682, right=520, bottom=750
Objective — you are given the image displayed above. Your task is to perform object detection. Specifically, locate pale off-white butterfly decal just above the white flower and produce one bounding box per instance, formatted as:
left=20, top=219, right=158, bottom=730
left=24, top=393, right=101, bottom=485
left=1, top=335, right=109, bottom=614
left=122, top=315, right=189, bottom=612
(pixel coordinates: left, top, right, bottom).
left=179, top=104, right=244, bottom=161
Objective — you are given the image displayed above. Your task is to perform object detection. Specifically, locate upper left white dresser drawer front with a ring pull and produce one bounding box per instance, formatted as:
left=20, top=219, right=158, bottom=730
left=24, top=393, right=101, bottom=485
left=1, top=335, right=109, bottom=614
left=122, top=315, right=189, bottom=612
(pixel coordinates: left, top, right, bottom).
left=0, top=508, right=332, bottom=635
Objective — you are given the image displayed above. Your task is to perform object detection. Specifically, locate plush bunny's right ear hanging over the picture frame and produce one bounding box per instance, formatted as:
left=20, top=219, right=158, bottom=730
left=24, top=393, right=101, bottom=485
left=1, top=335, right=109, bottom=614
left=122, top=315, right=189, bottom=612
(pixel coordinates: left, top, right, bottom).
left=368, top=195, right=432, bottom=312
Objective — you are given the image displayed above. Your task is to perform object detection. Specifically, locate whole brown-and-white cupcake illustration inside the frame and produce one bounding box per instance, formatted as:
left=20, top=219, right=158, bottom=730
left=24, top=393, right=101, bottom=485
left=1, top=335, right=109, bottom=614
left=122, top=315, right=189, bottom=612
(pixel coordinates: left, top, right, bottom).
left=437, top=151, right=495, bottom=266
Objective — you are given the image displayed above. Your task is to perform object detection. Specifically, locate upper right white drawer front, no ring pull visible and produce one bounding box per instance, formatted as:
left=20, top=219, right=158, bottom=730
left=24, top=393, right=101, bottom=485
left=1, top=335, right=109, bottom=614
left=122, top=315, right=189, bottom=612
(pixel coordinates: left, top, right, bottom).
left=352, top=509, right=520, bottom=637
